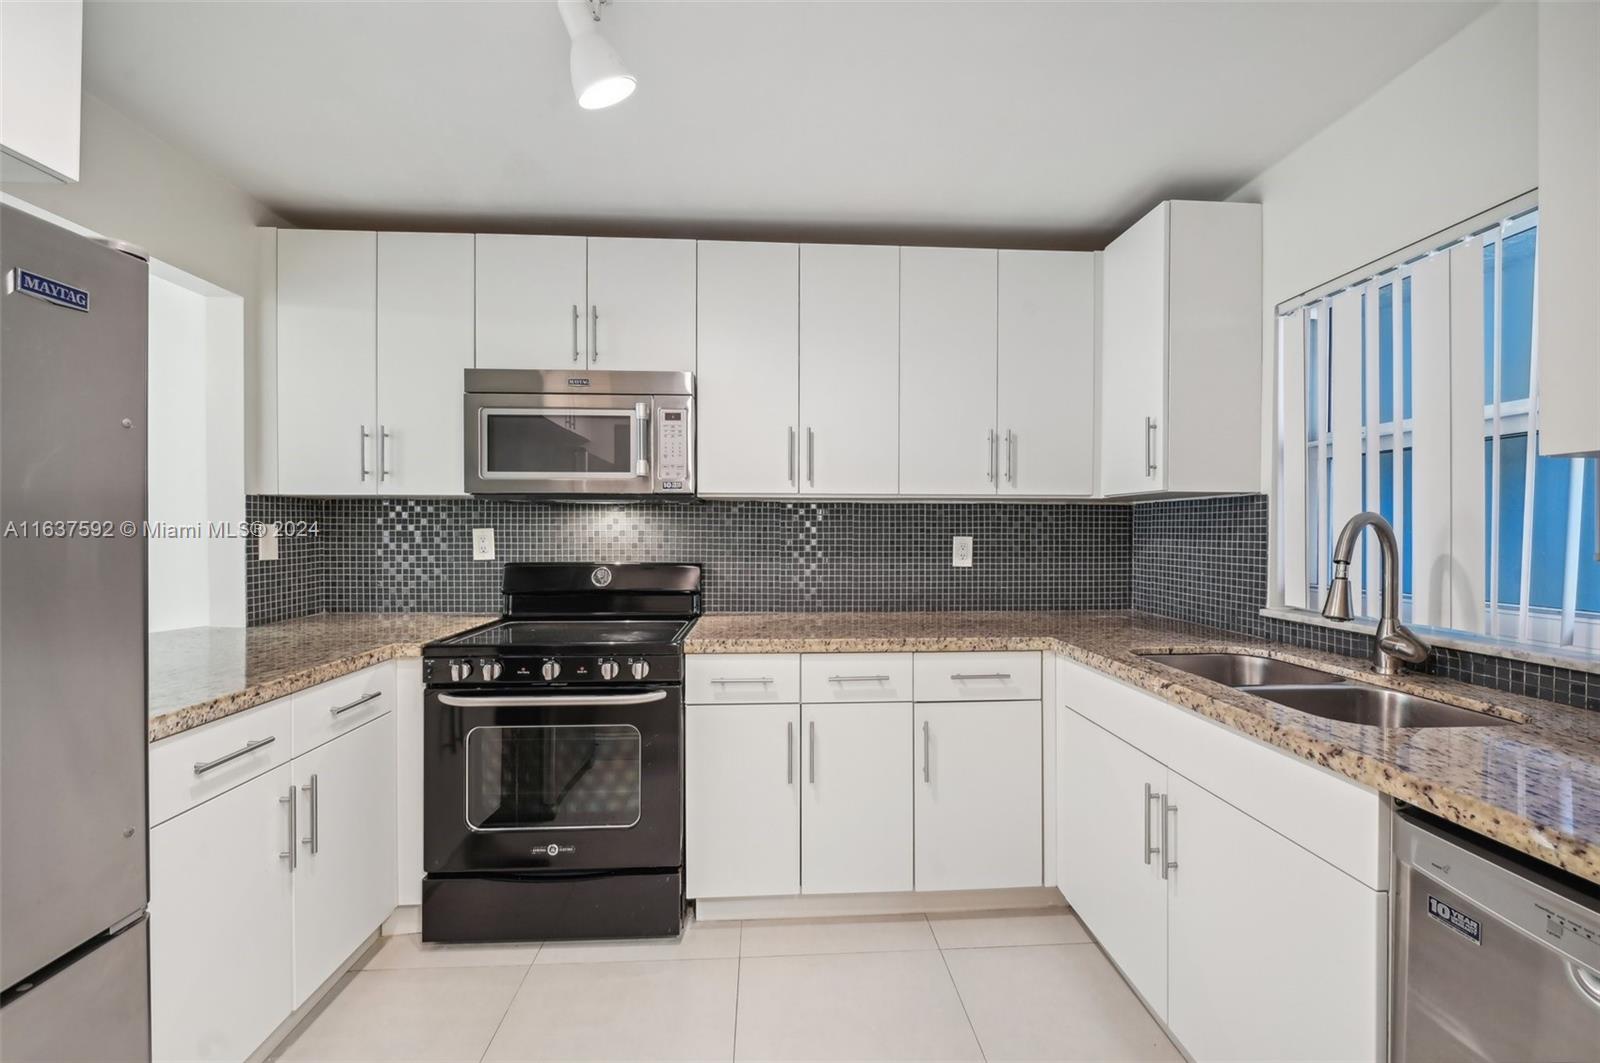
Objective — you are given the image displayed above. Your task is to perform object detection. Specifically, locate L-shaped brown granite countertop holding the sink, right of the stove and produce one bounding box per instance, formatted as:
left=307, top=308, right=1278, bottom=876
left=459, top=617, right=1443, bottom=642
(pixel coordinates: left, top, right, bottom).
left=686, top=612, right=1600, bottom=882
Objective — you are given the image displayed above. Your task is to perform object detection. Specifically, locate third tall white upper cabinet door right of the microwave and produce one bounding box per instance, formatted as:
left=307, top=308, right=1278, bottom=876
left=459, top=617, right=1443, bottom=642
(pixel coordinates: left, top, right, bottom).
left=899, top=247, right=1000, bottom=496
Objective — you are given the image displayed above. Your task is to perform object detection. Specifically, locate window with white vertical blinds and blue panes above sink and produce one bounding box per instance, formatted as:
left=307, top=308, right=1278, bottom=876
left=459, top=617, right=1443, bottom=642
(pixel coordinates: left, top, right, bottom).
left=1277, top=200, right=1600, bottom=648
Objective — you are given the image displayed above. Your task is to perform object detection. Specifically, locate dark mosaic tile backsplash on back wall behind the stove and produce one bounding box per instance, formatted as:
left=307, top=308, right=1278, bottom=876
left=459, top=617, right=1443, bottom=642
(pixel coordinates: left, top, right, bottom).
left=246, top=496, right=1131, bottom=624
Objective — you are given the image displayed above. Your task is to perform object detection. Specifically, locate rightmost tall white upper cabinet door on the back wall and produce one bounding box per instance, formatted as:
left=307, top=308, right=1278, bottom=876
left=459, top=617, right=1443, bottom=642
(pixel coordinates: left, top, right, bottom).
left=998, top=251, right=1094, bottom=496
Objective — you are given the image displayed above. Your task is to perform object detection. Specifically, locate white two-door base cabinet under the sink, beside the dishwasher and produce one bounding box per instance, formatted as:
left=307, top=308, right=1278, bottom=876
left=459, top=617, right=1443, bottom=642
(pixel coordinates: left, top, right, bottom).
left=1056, top=661, right=1389, bottom=1063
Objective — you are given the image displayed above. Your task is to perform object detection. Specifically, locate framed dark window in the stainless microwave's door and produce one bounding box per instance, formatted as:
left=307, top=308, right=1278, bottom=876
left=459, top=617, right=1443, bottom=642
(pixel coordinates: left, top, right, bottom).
left=483, top=410, right=637, bottom=475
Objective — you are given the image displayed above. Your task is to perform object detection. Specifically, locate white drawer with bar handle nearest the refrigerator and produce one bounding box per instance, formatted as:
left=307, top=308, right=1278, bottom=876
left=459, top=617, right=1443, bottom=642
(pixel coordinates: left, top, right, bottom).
left=150, top=698, right=293, bottom=826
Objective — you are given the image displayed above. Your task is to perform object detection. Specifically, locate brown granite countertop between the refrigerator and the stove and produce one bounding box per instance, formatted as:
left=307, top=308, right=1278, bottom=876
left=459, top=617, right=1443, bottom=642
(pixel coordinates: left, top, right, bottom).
left=149, top=613, right=494, bottom=741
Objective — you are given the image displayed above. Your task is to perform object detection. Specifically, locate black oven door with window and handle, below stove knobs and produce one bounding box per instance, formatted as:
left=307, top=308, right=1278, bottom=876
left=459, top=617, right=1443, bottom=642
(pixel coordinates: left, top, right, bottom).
left=422, top=687, right=683, bottom=874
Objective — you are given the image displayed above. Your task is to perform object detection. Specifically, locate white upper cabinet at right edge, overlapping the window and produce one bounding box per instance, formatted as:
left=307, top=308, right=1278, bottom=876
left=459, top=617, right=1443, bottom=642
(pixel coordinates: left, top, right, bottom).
left=1538, top=3, right=1600, bottom=455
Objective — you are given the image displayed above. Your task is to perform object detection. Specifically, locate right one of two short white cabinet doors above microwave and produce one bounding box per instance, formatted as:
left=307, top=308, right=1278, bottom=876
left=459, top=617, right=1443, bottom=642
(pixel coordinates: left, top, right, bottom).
left=589, top=237, right=694, bottom=373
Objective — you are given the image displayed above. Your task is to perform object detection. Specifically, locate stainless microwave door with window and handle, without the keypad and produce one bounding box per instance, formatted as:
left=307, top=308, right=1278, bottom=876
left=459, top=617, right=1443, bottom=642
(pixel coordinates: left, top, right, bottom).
left=464, top=392, right=654, bottom=495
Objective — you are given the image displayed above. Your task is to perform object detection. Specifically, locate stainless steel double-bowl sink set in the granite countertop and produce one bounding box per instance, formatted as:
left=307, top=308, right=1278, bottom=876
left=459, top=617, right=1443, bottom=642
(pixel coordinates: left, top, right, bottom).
left=1139, top=652, right=1517, bottom=727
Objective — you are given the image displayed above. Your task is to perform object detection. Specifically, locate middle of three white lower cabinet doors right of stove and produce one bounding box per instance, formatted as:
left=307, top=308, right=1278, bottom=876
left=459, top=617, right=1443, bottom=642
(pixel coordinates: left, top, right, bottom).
left=800, top=701, right=912, bottom=893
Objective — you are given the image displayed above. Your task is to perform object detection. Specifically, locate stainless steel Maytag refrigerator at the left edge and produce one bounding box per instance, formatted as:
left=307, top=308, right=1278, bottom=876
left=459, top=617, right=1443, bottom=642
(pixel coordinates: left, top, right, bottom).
left=0, top=207, right=150, bottom=1061
